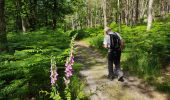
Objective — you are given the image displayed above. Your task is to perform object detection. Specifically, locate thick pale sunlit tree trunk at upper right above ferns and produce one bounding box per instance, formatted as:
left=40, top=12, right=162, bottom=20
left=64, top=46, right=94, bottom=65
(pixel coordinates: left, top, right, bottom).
left=147, top=0, right=153, bottom=30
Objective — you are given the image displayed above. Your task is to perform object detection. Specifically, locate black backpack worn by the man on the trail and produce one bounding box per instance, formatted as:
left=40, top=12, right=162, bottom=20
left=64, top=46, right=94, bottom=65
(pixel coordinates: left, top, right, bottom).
left=109, top=32, right=121, bottom=50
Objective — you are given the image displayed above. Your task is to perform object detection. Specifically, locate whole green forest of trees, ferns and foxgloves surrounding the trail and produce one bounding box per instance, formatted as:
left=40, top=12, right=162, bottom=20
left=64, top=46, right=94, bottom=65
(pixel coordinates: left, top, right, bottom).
left=0, top=0, right=170, bottom=100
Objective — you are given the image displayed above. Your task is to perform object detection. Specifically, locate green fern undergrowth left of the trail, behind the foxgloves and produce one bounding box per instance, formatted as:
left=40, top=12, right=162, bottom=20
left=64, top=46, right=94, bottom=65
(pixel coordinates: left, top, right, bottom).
left=0, top=28, right=83, bottom=100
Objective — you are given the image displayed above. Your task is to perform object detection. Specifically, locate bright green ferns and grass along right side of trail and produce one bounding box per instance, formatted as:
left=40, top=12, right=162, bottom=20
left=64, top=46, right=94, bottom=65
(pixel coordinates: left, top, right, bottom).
left=78, top=22, right=170, bottom=77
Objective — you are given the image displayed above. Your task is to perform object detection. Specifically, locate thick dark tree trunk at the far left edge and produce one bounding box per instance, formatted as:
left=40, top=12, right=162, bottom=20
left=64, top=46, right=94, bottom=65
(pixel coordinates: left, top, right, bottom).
left=0, top=0, right=8, bottom=52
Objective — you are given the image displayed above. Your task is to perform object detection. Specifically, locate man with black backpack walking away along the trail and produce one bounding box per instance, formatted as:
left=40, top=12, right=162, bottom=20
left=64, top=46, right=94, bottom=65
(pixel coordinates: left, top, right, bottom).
left=103, top=27, right=124, bottom=81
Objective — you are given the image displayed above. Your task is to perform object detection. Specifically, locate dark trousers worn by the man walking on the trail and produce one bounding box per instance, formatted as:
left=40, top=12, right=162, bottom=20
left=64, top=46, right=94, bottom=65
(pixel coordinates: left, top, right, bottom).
left=108, top=50, right=121, bottom=76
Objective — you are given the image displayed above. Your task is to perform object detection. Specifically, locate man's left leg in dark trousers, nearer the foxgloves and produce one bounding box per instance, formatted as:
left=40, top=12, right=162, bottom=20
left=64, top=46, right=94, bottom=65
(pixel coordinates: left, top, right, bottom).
left=108, top=51, right=113, bottom=78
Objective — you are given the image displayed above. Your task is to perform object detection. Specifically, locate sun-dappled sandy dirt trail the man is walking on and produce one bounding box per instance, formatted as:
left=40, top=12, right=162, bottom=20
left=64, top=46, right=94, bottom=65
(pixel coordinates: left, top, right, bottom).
left=76, top=41, right=168, bottom=100
